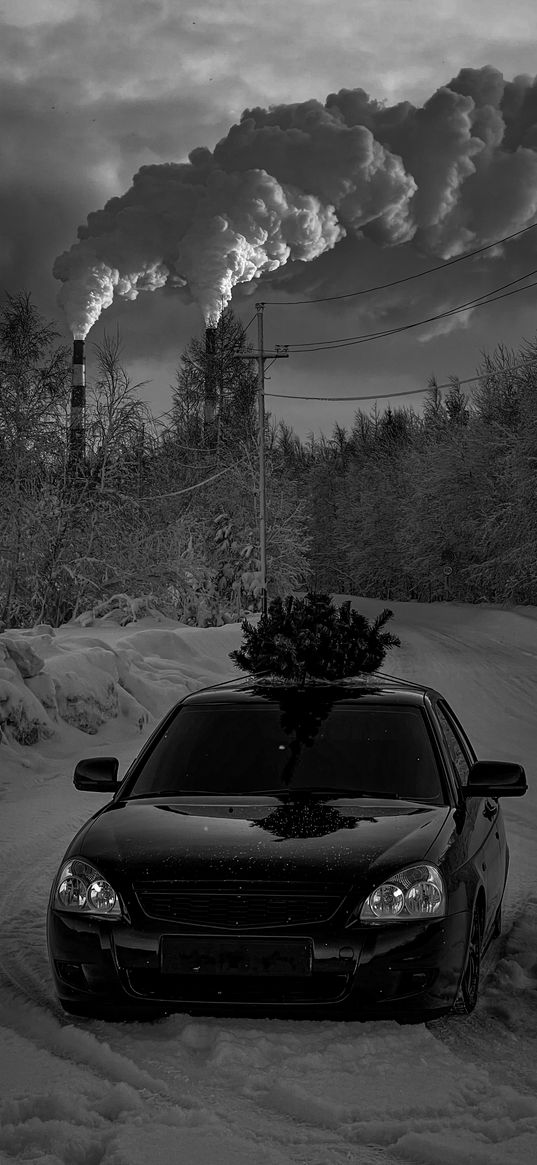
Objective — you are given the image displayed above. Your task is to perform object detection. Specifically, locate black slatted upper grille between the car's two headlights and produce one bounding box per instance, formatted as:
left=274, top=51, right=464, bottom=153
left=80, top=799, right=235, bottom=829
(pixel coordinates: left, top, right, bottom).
left=135, top=882, right=346, bottom=931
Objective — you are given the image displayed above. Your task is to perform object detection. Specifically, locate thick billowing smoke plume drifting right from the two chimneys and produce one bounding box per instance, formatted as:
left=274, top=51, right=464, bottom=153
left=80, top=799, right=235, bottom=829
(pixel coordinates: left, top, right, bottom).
left=54, top=65, right=537, bottom=337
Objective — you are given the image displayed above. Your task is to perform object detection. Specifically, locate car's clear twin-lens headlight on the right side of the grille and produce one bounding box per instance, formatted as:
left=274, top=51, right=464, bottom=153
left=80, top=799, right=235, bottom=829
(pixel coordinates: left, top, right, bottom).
left=353, top=863, right=446, bottom=923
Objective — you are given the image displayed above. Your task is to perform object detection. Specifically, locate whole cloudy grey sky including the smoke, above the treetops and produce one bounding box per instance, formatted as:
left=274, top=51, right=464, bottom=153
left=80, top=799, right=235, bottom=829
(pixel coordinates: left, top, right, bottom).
left=0, top=0, right=537, bottom=436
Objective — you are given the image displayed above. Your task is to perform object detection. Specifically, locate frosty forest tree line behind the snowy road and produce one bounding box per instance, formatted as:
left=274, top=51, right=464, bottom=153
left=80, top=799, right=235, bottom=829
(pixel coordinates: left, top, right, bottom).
left=0, top=294, right=537, bottom=627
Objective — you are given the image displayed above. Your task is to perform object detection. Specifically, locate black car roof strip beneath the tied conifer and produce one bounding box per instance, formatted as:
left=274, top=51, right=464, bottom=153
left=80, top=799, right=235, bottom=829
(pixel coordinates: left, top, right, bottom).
left=181, top=672, right=439, bottom=707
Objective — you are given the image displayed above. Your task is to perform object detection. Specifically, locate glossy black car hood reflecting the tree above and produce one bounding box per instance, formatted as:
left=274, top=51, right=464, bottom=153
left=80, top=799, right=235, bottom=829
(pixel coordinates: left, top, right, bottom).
left=75, top=797, right=453, bottom=881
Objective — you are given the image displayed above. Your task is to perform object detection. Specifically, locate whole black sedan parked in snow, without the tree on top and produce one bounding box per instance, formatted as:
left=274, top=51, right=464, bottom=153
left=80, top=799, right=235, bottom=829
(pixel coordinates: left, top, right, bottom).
left=48, top=675, right=527, bottom=1019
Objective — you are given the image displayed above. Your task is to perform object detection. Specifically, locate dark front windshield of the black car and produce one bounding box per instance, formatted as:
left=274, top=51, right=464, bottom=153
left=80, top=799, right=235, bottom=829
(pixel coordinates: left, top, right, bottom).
left=126, top=704, right=445, bottom=805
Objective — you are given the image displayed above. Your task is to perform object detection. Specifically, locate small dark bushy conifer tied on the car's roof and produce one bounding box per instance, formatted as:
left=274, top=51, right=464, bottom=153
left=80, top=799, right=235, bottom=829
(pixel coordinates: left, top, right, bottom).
left=229, top=592, right=400, bottom=683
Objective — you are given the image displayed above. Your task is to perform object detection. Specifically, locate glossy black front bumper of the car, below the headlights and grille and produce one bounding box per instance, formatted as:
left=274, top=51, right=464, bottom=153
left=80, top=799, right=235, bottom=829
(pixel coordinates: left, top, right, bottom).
left=48, top=909, right=469, bottom=1018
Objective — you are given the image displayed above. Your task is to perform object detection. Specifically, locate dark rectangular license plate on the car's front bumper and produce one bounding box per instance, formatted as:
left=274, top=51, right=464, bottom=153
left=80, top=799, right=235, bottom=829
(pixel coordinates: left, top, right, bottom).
left=161, top=935, right=312, bottom=976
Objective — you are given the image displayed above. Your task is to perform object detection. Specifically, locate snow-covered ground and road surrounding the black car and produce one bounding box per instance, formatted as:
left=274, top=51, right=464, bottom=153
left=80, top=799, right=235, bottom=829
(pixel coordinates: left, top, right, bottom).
left=0, top=600, right=537, bottom=1165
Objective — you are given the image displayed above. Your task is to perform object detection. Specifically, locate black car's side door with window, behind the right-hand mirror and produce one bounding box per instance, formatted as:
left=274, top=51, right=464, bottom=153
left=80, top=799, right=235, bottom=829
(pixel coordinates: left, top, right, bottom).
left=436, top=699, right=506, bottom=930
